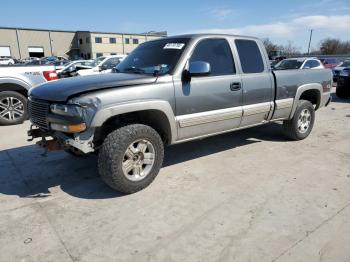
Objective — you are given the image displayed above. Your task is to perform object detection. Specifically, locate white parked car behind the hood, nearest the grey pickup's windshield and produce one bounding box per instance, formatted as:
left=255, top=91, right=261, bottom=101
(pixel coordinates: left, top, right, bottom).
left=78, top=55, right=126, bottom=76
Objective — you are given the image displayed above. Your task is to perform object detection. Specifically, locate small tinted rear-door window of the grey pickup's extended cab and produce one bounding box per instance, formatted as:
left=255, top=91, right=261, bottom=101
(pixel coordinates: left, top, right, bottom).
left=235, top=39, right=264, bottom=74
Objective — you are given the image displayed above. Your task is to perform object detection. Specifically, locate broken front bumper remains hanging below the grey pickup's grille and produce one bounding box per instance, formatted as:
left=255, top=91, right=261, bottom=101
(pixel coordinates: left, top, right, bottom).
left=27, top=126, right=95, bottom=154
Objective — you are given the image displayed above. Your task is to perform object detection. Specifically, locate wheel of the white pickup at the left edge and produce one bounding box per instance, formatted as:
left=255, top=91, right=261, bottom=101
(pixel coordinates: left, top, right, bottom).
left=0, top=91, right=27, bottom=125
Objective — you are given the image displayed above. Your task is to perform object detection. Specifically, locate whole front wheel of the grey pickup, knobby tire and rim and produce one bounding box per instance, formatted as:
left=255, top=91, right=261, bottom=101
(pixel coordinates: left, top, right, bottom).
left=98, top=124, right=164, bottom=194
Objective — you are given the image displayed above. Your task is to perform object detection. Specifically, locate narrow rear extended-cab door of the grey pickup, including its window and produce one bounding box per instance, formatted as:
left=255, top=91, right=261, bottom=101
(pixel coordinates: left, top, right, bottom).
left=234, top=38, right=274, bottom=126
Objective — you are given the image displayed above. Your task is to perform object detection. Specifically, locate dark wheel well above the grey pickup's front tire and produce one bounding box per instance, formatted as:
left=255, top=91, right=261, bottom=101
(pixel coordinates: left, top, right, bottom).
left=94, top=110, right=171, bottom=147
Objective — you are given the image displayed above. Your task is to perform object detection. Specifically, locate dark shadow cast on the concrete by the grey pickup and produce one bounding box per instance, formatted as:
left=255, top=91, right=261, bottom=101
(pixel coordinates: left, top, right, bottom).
left=0, top=123, right=286, bottom=199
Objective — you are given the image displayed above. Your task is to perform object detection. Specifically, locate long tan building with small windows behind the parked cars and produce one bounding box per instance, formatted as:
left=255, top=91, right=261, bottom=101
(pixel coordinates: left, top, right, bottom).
left=0, top=27, right=167, bottom=59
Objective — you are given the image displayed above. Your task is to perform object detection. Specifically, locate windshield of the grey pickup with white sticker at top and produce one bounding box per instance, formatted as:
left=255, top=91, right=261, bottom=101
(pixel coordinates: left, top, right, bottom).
left=115, top=38, right=190, bottom=75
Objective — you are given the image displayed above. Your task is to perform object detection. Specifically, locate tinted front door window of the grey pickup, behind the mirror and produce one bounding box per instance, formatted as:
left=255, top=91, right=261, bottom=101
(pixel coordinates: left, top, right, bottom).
left=190, top=39, right=236, bottom=76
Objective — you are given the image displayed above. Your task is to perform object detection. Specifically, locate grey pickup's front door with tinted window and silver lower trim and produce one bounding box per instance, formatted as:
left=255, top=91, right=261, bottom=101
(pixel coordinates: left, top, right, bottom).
left=174, top=37, right=242, bottom=140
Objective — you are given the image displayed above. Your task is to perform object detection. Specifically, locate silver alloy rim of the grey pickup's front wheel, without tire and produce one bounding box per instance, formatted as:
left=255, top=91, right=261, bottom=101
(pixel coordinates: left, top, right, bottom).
left=122, top=139, right=155, bottom=181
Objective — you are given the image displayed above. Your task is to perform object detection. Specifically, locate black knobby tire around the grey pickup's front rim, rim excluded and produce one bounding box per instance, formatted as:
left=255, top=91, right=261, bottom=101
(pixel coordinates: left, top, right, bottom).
left=98, top=124, right=164, bottom=194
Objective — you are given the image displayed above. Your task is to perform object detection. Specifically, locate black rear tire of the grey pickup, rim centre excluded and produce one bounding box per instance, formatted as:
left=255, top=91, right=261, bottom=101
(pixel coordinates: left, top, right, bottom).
left=283, top=100, right=315, bottom=140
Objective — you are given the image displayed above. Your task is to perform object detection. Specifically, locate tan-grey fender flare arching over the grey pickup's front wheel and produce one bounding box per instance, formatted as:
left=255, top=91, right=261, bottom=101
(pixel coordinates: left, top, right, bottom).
left=90, top=100, right=177, bottom=144
